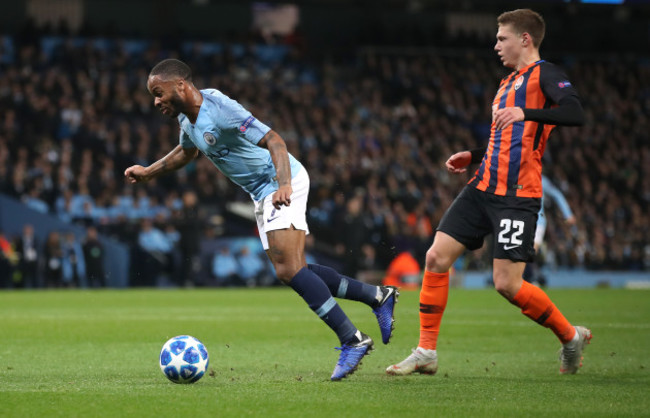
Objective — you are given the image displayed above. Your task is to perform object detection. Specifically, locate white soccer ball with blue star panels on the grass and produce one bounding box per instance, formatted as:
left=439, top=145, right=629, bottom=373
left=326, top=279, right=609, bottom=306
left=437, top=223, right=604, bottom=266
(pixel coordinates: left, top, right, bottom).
left=160, top=335, right=209, bottom=383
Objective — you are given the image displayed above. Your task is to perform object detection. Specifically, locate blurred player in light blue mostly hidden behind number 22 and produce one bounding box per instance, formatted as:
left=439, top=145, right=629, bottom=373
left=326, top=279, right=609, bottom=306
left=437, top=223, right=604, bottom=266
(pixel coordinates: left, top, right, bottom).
left=523, top=174, right=576, bottom=286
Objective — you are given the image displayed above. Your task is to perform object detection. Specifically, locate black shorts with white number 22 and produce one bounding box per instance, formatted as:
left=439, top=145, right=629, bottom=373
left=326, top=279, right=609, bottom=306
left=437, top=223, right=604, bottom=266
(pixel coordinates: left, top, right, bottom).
left=437, top=186, right=541, bottom=262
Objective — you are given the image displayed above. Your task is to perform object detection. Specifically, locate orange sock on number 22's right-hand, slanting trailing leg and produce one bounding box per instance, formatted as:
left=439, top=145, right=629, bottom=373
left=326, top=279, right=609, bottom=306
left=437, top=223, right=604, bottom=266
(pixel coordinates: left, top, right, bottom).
left=508, top=281, right=575, bottom=344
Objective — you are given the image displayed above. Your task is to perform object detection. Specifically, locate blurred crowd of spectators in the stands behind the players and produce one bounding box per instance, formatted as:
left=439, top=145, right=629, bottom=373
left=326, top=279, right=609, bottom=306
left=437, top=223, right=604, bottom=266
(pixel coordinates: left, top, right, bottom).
left=0, top=31, right=650, bottom=283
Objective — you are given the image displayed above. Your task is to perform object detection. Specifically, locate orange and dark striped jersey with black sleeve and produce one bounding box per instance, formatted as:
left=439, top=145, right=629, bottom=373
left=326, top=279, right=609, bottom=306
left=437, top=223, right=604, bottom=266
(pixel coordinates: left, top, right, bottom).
left=468, top=60, right=578, bottom=197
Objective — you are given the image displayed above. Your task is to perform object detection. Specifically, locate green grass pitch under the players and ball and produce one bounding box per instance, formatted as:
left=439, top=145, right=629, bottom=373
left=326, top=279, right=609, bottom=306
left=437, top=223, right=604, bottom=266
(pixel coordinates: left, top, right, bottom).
left=0, top=288, right=650, bottom=417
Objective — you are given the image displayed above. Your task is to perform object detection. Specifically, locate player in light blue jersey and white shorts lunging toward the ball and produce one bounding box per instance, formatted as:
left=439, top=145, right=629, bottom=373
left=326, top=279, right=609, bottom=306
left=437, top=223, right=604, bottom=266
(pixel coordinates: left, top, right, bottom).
left=124, top=59, right=399, bottom=380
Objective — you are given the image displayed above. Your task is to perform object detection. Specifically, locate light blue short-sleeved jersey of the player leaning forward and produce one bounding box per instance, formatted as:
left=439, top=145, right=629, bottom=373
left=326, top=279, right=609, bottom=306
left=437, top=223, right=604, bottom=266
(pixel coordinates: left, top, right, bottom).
left=178, top=89, right=302, bottom=201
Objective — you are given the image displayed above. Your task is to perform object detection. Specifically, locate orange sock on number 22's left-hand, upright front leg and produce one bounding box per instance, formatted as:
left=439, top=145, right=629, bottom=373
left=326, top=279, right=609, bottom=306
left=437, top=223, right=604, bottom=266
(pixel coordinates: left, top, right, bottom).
left=418, top=270, right=449, bottom=350
